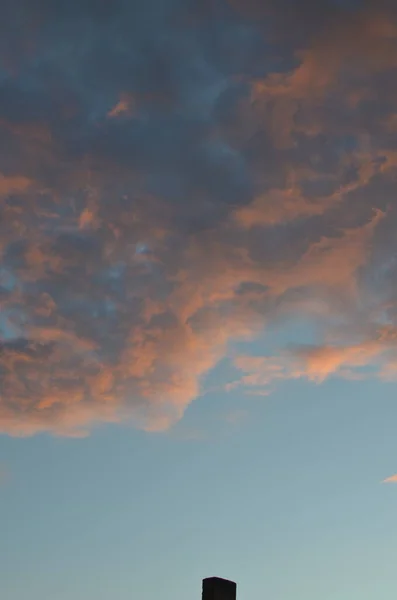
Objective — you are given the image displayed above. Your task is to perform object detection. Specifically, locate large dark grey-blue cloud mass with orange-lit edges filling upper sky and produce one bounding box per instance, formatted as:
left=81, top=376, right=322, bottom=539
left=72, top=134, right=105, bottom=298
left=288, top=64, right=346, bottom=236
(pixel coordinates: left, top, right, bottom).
left=0, top=0, right=397, bottom=436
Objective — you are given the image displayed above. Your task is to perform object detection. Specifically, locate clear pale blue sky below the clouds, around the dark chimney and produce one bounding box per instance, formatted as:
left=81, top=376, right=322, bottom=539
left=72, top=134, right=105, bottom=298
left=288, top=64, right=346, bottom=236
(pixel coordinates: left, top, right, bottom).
left=0, top=372, right=397, bottom=600
